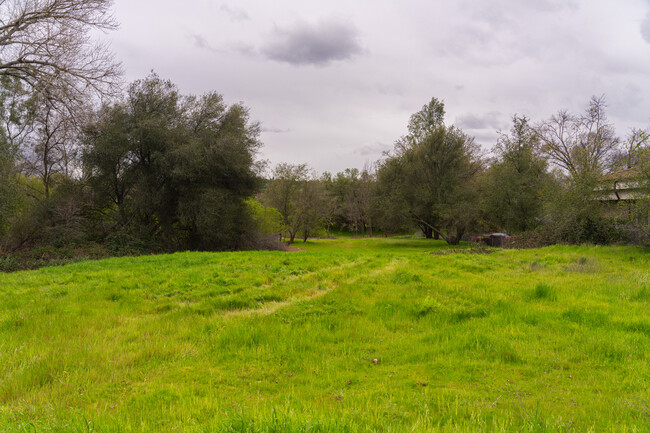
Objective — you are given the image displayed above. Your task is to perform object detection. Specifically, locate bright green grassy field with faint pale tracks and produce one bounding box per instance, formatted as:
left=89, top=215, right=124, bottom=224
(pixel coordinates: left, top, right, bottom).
left=0, top=238, right=650, bottom=432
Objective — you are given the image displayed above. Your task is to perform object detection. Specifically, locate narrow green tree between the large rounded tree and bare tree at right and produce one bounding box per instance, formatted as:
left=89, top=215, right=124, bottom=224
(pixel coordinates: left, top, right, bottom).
left=484, top=115, right=549, bottom=232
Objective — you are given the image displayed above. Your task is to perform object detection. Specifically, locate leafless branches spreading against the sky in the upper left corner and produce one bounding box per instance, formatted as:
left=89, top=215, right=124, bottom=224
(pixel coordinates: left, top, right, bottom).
left=0, top=0, right=121, bottom=111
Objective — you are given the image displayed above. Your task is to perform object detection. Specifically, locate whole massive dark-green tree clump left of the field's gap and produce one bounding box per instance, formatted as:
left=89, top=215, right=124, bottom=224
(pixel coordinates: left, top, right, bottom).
left=84, top=74, right=259, bottom=250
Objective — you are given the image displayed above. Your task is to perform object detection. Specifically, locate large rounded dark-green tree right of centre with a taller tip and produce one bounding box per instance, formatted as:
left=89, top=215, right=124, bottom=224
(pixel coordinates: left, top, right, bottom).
left=378, top=98, right=482, bottom=244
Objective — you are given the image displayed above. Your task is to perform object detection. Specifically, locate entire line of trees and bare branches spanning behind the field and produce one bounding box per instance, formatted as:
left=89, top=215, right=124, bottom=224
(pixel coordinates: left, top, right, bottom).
left=0, top=0, right=650, bottom=266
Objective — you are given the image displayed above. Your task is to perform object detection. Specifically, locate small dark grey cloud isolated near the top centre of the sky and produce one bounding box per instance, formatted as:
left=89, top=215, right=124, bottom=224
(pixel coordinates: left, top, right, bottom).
left=262, top=19, right=362, bottom=66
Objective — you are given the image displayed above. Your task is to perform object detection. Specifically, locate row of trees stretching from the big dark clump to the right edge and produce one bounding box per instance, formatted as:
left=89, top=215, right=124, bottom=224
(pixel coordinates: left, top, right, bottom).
left=259, top=97, right=650, bottom=245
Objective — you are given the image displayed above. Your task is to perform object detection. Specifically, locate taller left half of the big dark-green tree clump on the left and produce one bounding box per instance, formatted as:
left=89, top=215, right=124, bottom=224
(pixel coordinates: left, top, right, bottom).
left=83, top=74, right=182, bottom=240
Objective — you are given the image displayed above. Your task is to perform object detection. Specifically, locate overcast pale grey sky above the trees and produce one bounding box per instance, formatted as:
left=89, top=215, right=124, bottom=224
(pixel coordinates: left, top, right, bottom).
left=109, top=0, right=650, bottom=172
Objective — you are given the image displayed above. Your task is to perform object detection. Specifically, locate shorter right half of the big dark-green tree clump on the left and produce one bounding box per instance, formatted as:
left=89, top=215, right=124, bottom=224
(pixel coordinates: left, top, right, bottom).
left=175, top=93, right=261, bottom=249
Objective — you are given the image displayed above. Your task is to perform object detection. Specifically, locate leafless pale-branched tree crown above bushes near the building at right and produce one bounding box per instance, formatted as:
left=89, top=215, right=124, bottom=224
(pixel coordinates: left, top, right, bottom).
left=536, top=96, right=618, bottom=178
